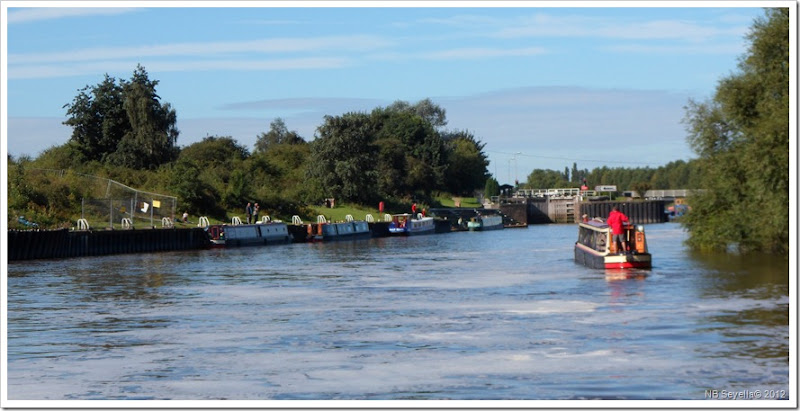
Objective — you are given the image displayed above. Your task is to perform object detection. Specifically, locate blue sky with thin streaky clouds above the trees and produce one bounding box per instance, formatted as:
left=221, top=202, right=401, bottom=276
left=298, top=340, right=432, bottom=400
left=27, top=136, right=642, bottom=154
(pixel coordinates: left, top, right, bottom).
left=2, top=1, right=776, bottom=184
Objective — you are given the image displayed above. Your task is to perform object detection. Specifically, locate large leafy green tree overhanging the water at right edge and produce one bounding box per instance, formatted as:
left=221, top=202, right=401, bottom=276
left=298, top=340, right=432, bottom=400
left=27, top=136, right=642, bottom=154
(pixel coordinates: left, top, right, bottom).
left=684, top=8, right=789, bottom=253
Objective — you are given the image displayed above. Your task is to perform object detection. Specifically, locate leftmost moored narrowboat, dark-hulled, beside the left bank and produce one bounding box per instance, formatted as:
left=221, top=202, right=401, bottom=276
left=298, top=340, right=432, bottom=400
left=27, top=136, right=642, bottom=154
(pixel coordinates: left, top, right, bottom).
left=206, top=222, right=292, bottom=247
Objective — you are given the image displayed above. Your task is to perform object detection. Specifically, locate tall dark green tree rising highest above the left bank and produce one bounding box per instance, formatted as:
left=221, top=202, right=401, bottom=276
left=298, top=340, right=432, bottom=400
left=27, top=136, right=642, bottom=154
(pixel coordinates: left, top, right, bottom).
left=64, top=65, right=179, bottom=169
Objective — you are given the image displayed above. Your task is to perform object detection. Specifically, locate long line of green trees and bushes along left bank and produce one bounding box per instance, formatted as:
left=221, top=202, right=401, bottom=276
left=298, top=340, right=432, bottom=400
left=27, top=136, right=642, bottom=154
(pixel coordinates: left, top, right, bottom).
left=9, top=65, right=489, bottom=226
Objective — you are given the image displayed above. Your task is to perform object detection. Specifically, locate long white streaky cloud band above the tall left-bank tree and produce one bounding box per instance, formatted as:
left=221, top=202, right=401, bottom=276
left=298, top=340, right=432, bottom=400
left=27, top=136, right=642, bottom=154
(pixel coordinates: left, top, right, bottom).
left=8, top=35, right=393, bottom=79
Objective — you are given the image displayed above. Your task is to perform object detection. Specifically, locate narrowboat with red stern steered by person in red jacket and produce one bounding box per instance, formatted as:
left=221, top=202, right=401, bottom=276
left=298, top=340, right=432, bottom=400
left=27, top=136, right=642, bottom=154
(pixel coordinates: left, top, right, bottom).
left=575, top=219, right=652, bottom=269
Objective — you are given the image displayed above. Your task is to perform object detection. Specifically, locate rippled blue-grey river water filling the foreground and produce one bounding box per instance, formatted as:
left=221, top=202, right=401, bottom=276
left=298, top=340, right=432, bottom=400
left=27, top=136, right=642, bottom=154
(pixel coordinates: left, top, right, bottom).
left=7, top=223, right=790, bottom=406
